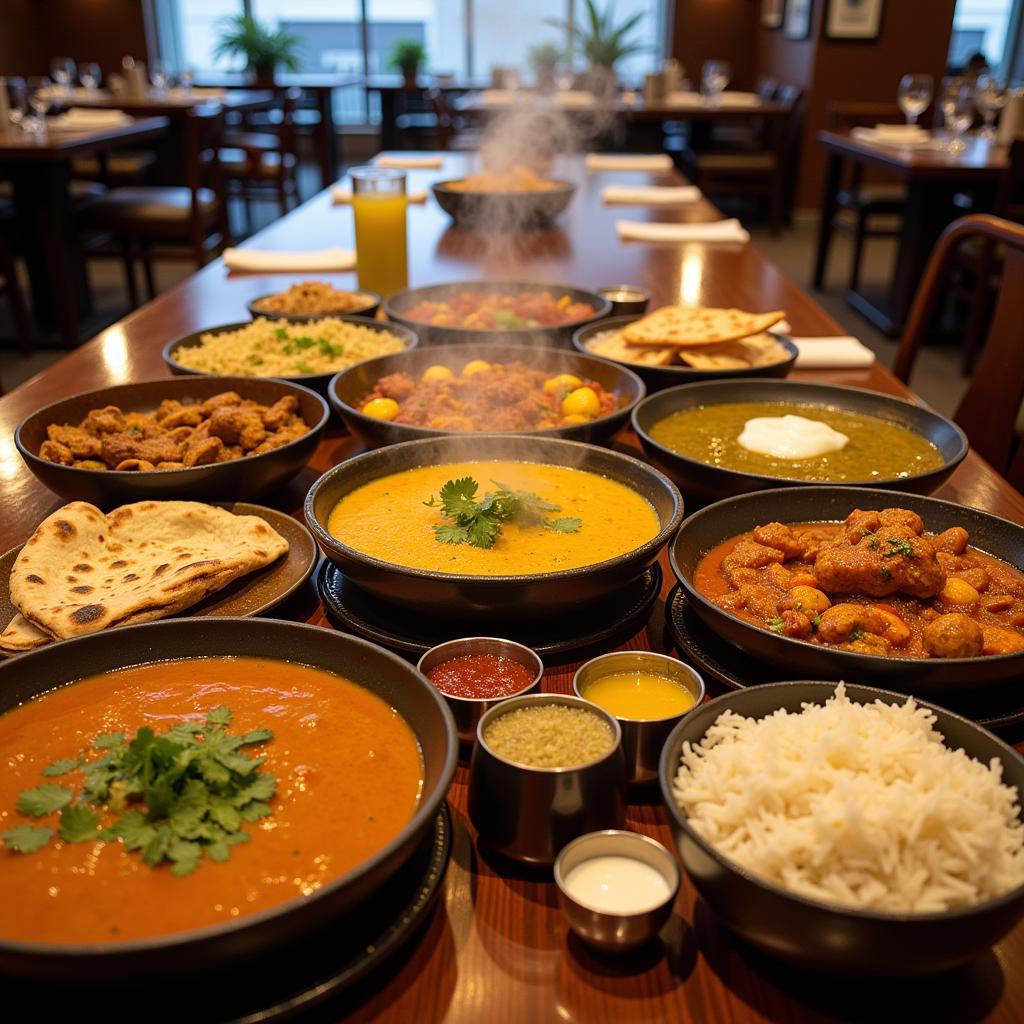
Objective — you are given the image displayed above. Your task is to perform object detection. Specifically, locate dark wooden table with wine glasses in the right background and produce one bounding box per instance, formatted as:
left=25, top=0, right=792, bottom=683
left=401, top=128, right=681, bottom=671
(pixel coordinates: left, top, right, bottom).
left=812, top=131, right=1009, bottom=335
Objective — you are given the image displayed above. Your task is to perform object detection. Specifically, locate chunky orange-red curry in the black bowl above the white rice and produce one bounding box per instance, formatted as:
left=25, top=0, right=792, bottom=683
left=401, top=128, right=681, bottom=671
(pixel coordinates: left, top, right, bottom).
left=693, top=508, right=1024, bottom=658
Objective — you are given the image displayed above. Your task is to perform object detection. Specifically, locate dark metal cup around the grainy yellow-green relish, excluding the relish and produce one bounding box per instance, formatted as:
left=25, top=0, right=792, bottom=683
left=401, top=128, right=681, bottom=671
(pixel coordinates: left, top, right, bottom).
left=469, top=693, right=626, bottom=864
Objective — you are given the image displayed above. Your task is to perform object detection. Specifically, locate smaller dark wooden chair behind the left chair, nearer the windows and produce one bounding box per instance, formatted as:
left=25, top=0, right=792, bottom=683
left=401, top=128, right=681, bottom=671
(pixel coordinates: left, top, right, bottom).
left=220, top=88, right=302, bottom=228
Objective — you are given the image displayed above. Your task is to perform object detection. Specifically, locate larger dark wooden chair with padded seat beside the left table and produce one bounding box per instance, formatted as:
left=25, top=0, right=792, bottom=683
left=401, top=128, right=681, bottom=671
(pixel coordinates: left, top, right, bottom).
left=79, top=104, right=229, bottom=304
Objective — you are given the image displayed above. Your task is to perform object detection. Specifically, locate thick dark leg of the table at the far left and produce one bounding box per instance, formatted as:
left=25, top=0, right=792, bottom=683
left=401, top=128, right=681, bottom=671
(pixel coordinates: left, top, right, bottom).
left=0, top=161, right=92, bottom=346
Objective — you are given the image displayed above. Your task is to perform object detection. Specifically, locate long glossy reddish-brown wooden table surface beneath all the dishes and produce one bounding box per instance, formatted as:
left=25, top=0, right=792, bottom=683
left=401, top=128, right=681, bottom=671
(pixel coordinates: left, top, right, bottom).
left=0, top=155, right=1024, bottom=1024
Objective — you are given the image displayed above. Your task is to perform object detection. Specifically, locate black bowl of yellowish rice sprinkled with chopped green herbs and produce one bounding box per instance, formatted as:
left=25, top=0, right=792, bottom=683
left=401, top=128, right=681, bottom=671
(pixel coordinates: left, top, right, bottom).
left=164, top=316, right=419, bottom=395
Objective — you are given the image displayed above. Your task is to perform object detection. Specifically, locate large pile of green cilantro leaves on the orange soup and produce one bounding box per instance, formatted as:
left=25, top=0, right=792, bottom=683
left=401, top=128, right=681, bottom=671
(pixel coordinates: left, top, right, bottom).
left=0, top=706, right=278, bottom=874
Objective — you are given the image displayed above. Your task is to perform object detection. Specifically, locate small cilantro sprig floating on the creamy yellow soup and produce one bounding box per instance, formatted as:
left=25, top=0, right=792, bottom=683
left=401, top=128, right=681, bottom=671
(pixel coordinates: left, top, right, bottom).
left=423, top=476, right=583, bottom=548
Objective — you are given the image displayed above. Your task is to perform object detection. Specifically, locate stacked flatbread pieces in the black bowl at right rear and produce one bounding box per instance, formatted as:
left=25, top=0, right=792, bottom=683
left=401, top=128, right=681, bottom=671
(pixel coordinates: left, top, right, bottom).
left=587, top=306, right=788, bottom=370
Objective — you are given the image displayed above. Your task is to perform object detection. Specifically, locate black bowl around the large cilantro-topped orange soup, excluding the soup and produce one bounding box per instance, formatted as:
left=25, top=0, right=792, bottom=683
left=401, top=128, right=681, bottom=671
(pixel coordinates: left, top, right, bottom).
left=0, top=618, right=459, bottom=984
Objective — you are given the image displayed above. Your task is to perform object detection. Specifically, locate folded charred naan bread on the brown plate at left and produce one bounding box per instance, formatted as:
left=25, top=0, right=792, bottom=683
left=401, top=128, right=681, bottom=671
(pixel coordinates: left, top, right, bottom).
left=0, top=502, right=288, bottom=651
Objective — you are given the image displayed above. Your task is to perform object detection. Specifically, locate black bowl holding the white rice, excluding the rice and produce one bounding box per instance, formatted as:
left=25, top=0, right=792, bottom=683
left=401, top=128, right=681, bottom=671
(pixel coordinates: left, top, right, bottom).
left=659, top=682, right=1024, bottom=976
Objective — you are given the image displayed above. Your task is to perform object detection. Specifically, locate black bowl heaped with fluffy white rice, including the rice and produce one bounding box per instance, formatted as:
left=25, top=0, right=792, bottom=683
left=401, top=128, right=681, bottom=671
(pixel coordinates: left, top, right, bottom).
left=659, top=682, right=1024, bottom=975
